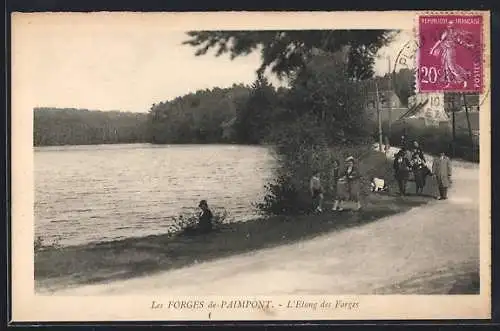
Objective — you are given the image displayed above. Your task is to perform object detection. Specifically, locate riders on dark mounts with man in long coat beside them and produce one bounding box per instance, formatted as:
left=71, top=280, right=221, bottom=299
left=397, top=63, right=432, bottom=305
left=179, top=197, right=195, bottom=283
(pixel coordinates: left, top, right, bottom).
left=393, top=141, right=451, bottom=200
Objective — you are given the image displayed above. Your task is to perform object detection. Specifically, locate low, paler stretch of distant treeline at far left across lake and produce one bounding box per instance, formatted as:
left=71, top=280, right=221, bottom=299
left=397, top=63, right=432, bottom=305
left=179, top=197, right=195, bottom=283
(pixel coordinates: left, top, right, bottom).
left=33, top=108, right=147, bottom=146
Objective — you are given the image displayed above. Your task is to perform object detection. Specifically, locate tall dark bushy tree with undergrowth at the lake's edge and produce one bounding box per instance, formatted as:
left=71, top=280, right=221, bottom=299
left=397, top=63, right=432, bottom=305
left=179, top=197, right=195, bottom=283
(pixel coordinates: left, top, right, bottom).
left=257, top=54, right=380, bottom=214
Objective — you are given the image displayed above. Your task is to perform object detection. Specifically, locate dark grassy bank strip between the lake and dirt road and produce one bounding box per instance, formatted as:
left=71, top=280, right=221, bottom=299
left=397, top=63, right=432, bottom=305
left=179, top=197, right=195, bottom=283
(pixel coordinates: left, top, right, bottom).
left=35, top=185, right=433, bottom=289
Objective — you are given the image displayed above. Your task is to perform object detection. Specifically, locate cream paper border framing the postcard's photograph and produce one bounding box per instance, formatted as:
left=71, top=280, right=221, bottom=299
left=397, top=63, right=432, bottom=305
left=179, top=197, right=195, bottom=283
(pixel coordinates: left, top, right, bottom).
left=11, top=11, right=491, bottom=322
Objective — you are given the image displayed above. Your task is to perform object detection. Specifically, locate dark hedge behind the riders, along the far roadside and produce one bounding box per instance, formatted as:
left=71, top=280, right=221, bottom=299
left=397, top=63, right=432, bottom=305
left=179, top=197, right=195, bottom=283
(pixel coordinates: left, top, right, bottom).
left=389, top=123, right=479, bottom=162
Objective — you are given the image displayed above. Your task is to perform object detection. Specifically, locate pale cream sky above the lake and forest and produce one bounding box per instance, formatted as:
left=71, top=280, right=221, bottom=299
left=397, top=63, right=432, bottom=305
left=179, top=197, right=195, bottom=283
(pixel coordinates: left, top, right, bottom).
left=12, top=14, right=411, bottom=112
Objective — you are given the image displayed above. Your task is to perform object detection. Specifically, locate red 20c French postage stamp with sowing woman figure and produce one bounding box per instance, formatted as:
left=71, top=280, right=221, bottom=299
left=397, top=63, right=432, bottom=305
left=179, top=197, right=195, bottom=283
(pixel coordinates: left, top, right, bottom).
left=417, top=15, right=483, bottom=93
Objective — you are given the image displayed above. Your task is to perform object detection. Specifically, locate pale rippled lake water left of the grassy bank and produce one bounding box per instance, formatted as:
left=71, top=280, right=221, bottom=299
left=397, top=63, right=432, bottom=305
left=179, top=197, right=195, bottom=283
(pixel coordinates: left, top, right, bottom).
left=34, top=144, right=274, bottom=246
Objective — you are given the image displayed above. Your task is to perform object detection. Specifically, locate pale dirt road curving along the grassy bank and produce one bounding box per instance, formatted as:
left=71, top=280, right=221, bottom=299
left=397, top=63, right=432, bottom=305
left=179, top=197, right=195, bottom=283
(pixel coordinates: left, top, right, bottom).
left=47, top=157, right=479, bottom=296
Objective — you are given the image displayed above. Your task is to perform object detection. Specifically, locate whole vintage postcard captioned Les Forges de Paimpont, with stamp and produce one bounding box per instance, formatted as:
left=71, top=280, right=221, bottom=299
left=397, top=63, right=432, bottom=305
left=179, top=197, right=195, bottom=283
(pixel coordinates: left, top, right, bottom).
left=11, top=11, right=491, bottom=322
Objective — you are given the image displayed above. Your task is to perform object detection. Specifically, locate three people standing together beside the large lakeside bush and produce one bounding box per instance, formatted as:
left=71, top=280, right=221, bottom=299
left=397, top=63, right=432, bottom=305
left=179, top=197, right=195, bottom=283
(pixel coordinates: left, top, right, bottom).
left=310, top=156, right=361, bottom=212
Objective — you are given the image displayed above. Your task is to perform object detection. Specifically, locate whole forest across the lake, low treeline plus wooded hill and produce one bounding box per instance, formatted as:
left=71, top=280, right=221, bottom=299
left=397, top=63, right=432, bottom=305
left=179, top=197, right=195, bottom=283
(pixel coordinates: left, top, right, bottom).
left=33, top=84, right=251, bottom=146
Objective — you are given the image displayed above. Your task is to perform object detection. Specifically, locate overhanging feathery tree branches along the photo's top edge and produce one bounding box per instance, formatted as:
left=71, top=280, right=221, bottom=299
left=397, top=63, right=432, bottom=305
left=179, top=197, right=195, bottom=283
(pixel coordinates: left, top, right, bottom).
left=184, top=30, right=396, bottom=79
